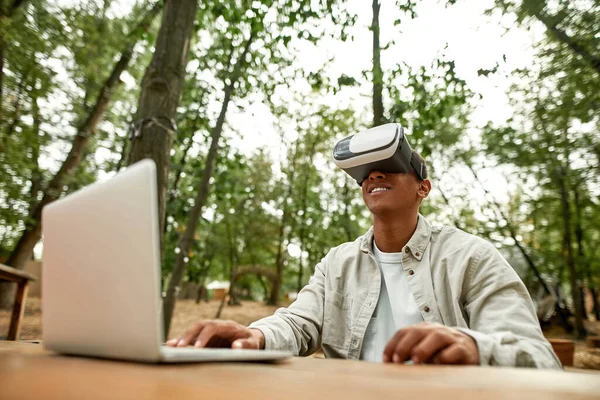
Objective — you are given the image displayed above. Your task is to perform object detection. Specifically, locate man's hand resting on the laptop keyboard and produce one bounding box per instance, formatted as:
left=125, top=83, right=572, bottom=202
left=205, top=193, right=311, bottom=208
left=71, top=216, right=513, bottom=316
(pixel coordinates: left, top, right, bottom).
left=166, top=320, right=265, bottom=349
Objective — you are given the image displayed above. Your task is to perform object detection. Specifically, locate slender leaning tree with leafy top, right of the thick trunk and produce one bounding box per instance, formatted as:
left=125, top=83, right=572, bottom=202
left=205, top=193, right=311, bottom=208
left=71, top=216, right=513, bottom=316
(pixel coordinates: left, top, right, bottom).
left=164, top=0, right=354, bottom=332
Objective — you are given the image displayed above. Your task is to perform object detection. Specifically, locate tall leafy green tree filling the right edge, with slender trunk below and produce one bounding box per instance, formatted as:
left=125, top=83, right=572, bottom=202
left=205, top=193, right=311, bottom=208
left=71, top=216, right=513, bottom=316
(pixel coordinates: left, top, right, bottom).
left=484, top=0, right=600, bottom=337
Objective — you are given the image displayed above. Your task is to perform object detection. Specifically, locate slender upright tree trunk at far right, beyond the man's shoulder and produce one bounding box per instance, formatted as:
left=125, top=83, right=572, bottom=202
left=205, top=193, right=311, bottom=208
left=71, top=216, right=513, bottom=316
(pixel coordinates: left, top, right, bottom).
left=556, top=167, right=586, bottom=338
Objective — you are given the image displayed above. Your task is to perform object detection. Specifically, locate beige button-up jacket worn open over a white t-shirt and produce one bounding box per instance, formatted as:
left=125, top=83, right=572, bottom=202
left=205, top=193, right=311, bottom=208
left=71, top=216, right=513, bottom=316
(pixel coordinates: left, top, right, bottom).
left=250, top=215, right=561, bottom=368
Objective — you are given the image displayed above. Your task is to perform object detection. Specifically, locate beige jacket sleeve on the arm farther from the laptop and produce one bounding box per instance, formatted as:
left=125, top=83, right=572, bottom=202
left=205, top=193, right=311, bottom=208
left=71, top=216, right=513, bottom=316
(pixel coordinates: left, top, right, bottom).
left=458, top=242, right=561, bottom=368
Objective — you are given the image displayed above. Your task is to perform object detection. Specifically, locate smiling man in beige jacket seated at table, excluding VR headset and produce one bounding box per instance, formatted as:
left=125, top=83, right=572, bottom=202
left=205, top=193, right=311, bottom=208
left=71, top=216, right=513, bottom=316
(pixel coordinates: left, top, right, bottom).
left=167, top=148, right=560, bottom=368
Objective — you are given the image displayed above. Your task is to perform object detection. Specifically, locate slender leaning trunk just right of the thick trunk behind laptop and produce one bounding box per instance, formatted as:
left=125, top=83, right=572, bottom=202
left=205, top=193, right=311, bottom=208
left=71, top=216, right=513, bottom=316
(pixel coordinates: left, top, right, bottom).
left=163, top=32, right=255, bottom=335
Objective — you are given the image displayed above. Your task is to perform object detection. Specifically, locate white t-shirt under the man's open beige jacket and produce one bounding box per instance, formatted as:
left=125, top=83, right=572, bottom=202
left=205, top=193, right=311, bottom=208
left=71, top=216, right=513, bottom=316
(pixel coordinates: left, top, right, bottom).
left=360, top=241, right=423, bottom=362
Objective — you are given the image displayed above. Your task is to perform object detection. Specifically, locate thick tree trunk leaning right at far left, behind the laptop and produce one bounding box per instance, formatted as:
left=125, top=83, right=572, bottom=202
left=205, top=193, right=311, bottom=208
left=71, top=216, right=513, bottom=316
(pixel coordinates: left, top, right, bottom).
left=0, top=3, right=160, bottom=308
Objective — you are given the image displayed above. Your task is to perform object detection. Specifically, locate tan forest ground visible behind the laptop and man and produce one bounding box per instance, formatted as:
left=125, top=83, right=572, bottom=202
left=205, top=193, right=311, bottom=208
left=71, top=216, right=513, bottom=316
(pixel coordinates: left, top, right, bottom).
left=0, top=298, right=600, bottom=370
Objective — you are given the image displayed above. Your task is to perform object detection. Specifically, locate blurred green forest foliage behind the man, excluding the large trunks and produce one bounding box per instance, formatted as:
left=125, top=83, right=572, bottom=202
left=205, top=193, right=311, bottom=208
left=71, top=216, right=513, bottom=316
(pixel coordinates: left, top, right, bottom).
left=0, top=0, right=600, bottom=322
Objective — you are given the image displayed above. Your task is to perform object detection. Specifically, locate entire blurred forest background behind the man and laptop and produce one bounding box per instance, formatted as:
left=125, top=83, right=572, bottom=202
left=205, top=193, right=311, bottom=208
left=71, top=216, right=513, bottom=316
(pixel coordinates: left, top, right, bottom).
left=0, top=0, right=600, bottom=366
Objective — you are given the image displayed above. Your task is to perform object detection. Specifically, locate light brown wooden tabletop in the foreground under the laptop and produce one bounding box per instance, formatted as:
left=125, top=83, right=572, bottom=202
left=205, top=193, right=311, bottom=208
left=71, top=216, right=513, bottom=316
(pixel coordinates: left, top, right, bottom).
left=0, top=341, right=600, bottom=400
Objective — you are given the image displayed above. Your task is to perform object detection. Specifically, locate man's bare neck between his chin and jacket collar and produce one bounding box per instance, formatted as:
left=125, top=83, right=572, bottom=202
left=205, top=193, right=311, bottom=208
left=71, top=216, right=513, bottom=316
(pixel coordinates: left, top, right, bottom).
left=373, top=213, right=419, bottom=253
